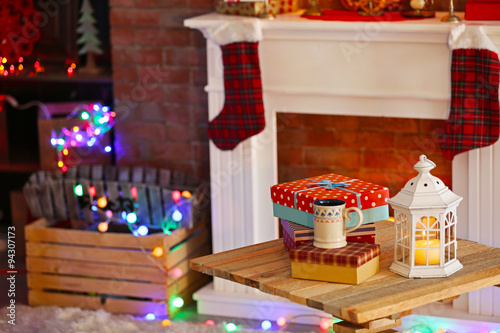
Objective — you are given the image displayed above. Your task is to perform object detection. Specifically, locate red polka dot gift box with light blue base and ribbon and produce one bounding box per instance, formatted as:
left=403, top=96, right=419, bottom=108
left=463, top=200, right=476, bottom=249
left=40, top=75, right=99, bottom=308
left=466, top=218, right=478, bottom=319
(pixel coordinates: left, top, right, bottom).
left=271, top=173, right=389, bottom=228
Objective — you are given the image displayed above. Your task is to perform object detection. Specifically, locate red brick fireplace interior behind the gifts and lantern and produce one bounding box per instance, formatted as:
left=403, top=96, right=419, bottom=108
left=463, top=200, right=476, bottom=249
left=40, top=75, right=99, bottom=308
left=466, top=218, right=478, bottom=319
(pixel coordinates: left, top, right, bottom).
left=277, top=113, right=452, bottom=197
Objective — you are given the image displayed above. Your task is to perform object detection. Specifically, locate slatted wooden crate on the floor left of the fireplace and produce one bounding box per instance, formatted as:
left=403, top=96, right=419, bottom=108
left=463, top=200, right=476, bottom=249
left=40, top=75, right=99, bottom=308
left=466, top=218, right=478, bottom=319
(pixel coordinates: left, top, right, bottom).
left=25, top=218, right=211, bottom=317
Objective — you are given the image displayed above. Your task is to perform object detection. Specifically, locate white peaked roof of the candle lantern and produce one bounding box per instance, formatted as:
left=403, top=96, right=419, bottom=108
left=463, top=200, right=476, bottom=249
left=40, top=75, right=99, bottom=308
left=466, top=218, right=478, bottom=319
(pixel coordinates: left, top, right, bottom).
left=387, top=155, right=463, bottom=210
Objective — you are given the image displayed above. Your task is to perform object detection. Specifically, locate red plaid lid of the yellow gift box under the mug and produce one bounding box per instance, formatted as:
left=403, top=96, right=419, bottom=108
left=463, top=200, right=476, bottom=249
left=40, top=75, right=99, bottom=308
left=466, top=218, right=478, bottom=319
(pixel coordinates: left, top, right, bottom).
left=290, top=241, right=380, bottom=268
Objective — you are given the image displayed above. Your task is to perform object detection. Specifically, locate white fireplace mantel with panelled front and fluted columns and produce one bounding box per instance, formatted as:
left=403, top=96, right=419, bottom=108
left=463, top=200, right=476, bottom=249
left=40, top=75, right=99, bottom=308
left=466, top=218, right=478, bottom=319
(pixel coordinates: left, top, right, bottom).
left=184, top=13, right=500, bottom=318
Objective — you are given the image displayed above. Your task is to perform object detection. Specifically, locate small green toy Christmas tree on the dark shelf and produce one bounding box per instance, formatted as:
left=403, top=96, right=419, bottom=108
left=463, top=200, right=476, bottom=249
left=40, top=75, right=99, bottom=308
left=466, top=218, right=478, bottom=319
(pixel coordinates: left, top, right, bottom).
left=76, top=0, right=102, bottom=74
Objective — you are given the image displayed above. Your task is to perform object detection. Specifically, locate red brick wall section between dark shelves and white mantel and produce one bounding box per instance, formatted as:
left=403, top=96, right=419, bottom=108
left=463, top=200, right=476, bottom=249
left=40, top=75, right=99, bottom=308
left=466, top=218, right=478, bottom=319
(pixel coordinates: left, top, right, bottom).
left=110, top=0, right=213, bottom=179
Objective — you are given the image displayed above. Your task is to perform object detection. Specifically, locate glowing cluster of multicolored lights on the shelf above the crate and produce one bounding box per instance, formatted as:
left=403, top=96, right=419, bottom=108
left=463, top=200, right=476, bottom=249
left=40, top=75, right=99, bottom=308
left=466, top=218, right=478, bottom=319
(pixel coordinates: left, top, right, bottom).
left=50, top=103, right=116, bottom=172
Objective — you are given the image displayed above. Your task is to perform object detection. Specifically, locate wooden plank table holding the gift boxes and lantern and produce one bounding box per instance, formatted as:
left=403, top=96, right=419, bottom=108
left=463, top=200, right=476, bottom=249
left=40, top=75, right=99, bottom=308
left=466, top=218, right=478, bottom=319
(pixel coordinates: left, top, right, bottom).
left=191, top=239, right=500, bottom=333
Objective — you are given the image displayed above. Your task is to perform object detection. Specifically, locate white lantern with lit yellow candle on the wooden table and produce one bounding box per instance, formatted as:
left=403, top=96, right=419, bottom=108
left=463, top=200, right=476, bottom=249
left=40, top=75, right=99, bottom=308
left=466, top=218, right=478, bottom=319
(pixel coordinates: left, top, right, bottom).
left=388, top=155, right=463, bottom=278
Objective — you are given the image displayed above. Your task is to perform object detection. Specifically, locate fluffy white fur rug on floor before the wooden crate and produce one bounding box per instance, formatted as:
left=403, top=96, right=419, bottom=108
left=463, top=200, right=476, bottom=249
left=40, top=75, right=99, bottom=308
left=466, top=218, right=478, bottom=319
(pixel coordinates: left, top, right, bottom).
left=0, top=305, right=290, bottom=333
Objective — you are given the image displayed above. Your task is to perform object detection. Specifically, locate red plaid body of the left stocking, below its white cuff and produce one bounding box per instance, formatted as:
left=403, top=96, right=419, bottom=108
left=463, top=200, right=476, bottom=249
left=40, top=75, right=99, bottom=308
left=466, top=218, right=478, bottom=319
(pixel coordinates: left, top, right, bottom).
left=208, top=42, right=266, bottom=150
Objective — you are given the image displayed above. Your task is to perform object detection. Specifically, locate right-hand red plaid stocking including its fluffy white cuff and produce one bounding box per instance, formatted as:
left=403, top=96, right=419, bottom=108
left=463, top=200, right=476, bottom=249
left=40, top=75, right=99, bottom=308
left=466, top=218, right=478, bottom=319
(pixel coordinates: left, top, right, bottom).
left=439, top=26, right=500, bottom=160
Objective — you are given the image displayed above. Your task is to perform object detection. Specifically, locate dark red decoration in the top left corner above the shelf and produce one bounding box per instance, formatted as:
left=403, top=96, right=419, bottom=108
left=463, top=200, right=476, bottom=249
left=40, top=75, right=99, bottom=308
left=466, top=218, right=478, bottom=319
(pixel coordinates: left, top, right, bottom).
left=0, top=0, right=41, bottom=61
